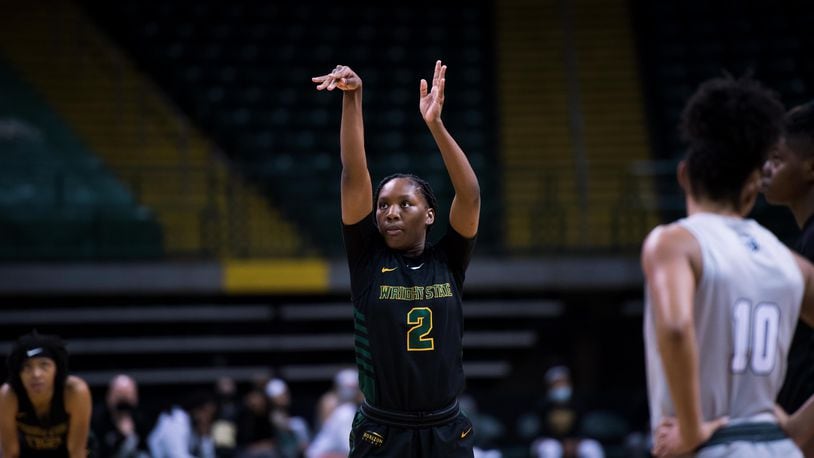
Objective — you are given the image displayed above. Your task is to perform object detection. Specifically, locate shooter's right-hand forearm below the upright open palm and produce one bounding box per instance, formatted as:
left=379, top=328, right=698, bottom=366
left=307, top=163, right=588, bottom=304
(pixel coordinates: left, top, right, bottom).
left=427, top=119, right=480, bottom=204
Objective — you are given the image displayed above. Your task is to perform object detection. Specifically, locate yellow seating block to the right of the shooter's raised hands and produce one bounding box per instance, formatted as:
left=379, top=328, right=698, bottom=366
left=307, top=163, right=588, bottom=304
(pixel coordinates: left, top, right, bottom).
left=495, top=0, right=656, bottom=255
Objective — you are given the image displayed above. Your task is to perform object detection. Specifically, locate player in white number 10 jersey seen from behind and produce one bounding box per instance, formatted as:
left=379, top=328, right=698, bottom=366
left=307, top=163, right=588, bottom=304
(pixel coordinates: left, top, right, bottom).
left=642, top=77, right=814, bottom=457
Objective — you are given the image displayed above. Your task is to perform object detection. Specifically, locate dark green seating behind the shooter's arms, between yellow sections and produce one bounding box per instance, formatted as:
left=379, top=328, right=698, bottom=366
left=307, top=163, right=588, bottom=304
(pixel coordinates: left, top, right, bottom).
left=85, top=1, right=500, bottom=255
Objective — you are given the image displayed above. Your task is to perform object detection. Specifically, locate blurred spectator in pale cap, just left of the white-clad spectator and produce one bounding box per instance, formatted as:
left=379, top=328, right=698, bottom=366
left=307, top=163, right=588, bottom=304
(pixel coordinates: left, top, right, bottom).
left=266, top=378, right=311, bottom=458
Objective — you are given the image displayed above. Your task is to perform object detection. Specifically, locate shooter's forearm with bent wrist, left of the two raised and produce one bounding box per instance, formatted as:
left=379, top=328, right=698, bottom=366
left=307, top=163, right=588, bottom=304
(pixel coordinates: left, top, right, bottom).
left=339, top=88, right=367, bottom=178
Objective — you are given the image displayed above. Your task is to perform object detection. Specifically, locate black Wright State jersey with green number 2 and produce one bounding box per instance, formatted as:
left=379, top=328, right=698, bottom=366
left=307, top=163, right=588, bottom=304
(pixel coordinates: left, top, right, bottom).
left=343, top=215, right=475, bottom=411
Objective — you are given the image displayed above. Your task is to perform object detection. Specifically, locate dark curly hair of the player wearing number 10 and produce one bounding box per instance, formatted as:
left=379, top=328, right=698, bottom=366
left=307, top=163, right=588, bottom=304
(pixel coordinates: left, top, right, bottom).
left=680, top=76, right=785, bottom=208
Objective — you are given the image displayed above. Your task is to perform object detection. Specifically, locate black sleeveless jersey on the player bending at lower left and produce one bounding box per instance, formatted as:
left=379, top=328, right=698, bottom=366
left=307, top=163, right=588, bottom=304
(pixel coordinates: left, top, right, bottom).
left=16, top=389, right=69, bottom=458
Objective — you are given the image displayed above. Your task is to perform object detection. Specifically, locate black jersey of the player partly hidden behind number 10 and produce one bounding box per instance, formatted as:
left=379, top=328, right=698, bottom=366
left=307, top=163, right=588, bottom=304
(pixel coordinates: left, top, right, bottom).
left=777, top=216, right=814, bottom=413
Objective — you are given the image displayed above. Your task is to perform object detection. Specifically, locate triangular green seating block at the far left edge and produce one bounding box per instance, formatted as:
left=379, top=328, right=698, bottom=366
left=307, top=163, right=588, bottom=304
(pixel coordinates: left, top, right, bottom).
left=0, top=57, right=163, bottom=260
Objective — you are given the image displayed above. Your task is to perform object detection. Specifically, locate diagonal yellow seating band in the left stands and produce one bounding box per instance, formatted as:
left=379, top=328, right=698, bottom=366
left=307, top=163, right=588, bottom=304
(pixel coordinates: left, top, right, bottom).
left=0, top=2, right=314, bottom=259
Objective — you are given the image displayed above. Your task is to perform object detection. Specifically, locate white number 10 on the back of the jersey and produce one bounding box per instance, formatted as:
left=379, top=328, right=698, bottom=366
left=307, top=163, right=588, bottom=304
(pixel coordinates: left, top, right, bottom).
left=732, top=299, right=780, bottom=375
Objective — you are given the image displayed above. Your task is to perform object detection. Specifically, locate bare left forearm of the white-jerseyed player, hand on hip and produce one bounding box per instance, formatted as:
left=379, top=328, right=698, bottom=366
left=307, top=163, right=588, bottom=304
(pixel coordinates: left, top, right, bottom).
left=656, top=322, right=703, bottom=443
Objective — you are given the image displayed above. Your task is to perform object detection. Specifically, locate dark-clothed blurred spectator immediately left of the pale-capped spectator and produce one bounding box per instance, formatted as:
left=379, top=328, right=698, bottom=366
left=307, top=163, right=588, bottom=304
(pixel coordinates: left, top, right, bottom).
left=237, top=386, right=276, bottom=458
